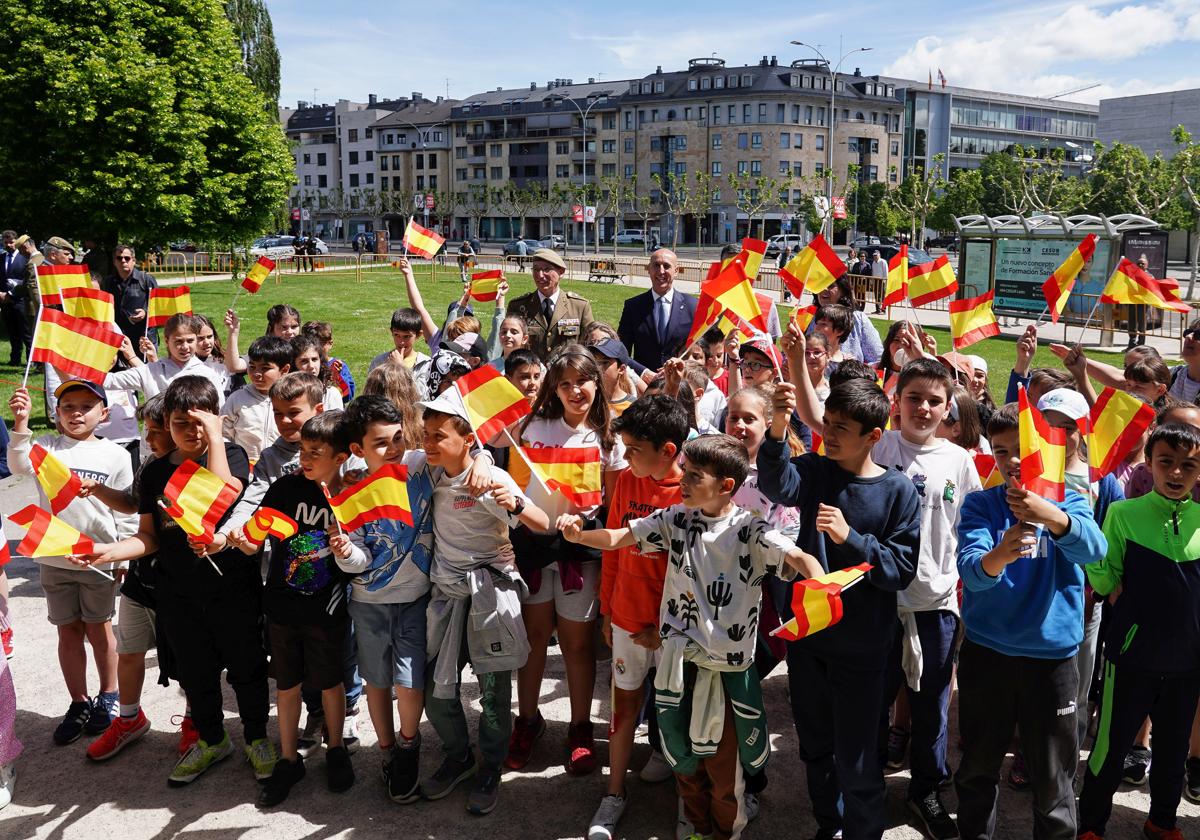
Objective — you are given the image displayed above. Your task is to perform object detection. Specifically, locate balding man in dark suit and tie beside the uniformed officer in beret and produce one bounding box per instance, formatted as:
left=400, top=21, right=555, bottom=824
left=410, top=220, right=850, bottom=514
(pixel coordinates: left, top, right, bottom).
left=617, top=248, right=696, bottom=371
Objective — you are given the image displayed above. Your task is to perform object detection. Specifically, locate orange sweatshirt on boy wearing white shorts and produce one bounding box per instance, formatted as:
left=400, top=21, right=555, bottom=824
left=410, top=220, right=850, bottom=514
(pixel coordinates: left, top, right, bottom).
left=600, top=468, right=683, bottom=632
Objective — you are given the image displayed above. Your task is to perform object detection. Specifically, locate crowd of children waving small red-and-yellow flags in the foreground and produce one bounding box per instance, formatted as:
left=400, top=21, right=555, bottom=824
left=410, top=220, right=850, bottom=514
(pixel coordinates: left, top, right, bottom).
left=0, top=264, right=1200, bottom=840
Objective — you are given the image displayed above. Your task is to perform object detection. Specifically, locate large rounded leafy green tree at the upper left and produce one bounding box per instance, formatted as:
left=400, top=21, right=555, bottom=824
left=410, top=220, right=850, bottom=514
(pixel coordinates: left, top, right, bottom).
left=0, top=0, right=295, bottom=247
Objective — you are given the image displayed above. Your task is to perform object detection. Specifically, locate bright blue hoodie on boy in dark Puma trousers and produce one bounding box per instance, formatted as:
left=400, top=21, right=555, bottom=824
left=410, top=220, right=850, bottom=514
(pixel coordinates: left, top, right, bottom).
left=959, top=485, right=1108, bottom=659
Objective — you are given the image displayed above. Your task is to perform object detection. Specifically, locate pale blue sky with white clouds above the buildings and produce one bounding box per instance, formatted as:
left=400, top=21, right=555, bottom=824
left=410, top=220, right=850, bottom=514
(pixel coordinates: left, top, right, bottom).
left=266, top=0, right=1200, bottom=108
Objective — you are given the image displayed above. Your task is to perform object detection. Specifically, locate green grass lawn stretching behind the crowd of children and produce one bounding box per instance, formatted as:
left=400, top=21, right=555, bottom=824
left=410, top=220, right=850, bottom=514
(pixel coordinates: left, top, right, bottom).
left=0, top=265, right=1142, bottom=428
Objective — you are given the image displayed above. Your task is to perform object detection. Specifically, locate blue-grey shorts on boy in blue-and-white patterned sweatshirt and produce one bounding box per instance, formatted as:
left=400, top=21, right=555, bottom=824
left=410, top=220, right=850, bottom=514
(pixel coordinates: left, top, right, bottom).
left=350, top=595, right=430, bottom=689
